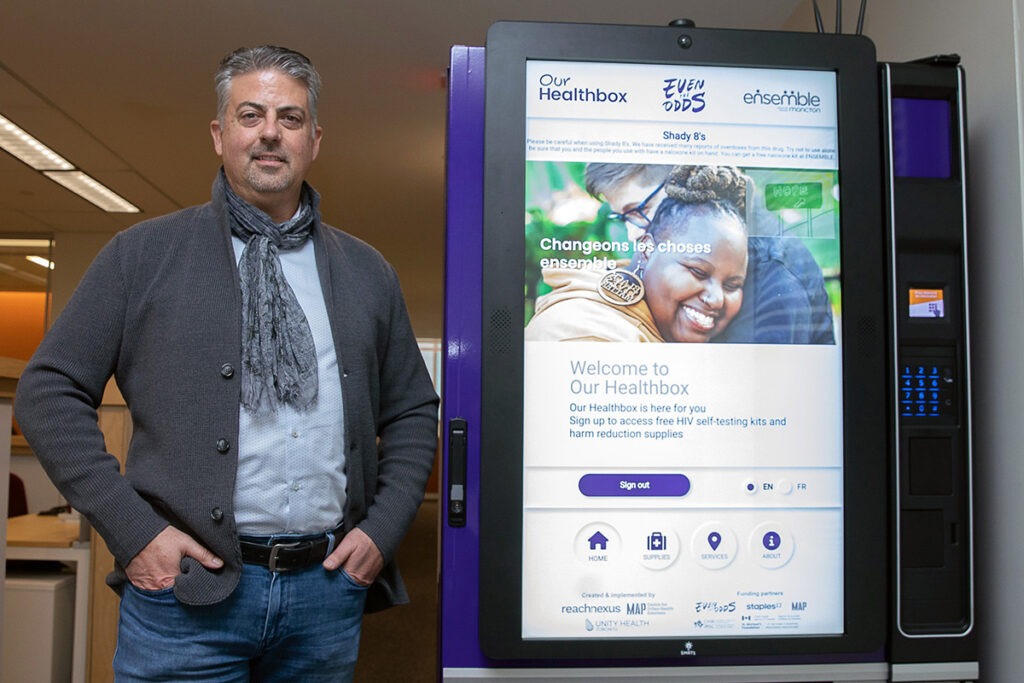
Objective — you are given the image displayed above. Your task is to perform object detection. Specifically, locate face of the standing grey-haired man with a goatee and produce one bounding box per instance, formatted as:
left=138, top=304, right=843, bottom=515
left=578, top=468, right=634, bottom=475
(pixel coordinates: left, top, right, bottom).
left=210, top=70, right=323, bottom=222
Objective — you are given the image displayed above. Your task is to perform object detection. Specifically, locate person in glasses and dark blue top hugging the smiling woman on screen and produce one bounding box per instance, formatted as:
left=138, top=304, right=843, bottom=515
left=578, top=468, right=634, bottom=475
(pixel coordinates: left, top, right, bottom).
left=585, top=163, right=835, bottom=344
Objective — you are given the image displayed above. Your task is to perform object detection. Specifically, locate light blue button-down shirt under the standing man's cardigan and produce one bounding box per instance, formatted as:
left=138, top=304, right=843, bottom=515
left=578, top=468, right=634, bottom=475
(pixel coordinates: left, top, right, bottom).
left=231, top=237, right=346, bottom=536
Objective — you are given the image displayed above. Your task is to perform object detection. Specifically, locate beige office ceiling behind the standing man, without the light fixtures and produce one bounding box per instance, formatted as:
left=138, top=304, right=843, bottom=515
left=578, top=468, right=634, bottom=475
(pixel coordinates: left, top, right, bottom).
left=0, top=0, right=813, bottom=336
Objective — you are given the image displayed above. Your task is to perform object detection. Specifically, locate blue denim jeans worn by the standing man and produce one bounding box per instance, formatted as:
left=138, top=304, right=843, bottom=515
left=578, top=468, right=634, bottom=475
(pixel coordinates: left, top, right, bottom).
left=114, top=564, right=367, bottom=683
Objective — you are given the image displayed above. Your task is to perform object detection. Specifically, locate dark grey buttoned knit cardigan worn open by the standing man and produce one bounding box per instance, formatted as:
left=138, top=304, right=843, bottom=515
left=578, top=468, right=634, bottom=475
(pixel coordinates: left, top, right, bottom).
left=15, top=176, right=437, bottom=610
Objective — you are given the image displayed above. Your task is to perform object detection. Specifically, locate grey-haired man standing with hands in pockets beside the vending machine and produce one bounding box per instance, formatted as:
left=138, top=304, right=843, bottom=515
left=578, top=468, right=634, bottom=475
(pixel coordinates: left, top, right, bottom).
left=16, top=46, right=437, bottom=682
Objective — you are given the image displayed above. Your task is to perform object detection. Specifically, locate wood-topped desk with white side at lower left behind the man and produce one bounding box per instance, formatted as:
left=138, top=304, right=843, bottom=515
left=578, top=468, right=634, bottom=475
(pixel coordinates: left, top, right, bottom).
left=7, top=515, right=89, bottom=683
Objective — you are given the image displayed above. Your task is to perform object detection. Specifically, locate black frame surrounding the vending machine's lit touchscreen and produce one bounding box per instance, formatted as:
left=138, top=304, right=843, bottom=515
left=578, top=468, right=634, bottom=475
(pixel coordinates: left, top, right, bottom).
left=479, top=23, right=891, bottom=665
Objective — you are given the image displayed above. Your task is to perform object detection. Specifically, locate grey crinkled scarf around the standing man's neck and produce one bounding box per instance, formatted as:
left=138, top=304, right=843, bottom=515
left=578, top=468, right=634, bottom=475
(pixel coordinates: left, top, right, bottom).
left=223, top=174, right=317, bottom=415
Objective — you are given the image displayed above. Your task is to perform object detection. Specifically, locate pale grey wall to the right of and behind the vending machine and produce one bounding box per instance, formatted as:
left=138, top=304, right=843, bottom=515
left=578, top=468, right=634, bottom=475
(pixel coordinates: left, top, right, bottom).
left=793, top=0, right=1024, bottom=683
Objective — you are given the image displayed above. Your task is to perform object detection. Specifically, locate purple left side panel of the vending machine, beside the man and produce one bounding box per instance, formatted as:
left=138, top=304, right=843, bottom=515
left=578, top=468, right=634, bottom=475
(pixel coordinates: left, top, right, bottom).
left=438, top=45, right=487, bottom=669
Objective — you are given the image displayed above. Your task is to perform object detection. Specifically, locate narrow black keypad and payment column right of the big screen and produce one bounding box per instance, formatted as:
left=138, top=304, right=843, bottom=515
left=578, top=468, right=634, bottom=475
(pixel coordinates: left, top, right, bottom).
left=881, top=55, right=977, bottom=671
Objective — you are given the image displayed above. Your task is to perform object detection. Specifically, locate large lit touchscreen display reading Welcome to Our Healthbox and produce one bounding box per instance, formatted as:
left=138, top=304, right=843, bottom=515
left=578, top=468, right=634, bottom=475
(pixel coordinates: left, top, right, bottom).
left=521, top=59, right=845, bottom=653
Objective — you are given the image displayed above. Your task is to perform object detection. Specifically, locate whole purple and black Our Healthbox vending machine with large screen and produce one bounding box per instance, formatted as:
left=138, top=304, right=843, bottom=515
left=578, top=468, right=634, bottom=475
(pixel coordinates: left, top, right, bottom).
left=439, top=23, right=978, bottom=682
